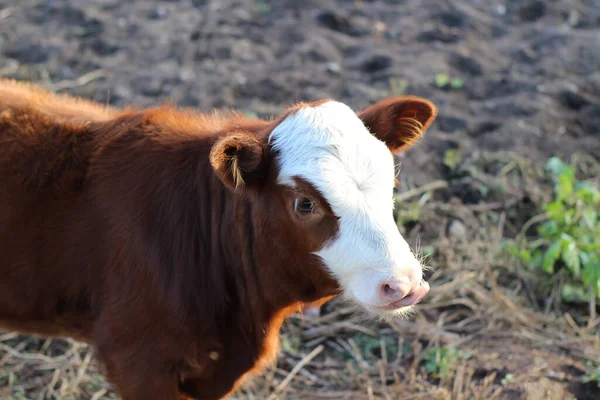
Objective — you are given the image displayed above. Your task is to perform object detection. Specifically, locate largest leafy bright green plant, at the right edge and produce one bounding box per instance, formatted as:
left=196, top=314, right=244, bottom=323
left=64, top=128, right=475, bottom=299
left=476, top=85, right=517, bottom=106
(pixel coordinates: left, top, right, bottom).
left=507, top=157, right=600, bottom=302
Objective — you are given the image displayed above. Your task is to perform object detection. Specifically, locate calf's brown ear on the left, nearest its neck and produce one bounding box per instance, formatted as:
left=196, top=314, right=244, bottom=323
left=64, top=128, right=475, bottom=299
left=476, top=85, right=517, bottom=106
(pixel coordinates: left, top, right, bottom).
left=210, top=131, right=268, bottom=189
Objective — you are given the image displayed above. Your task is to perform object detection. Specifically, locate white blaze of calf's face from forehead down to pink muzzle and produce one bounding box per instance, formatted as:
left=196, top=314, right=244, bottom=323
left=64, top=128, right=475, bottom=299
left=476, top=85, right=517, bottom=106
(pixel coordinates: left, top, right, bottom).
left=270, top=101, right=429, bottom=316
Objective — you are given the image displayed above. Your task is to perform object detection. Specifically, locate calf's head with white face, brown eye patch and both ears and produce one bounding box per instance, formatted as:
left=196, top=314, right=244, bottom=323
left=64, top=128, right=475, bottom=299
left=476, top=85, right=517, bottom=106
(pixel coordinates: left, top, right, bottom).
left=211, top=96, right=437, bottom=317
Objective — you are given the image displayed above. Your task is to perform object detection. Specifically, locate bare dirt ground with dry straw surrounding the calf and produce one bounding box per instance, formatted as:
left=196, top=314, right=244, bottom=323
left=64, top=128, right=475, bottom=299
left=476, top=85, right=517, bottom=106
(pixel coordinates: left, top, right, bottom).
left=0, top=0, right=600, bottom=400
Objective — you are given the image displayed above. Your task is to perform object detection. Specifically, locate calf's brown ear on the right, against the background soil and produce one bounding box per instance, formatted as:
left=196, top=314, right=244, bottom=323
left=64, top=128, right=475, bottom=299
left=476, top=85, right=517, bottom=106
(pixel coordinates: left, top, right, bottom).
left=358, top=96, right=437, bottom=153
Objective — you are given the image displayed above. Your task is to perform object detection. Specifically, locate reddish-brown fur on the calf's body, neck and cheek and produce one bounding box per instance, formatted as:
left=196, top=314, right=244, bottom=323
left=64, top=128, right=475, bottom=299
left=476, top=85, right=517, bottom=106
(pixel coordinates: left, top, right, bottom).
left=0, top=79, right=434, bottom=400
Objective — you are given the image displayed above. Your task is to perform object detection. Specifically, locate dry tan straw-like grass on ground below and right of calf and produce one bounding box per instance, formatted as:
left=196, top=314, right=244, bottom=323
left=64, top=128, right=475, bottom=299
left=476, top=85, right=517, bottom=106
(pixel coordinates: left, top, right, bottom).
left=0, top=152, right=600, bottom=400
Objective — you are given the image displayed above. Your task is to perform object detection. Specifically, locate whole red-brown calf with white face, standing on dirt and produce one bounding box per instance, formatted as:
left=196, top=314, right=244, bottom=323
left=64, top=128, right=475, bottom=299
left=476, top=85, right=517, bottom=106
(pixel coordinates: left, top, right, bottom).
left=0, top=80, right=437, bottom=400
